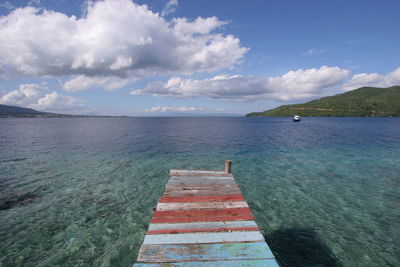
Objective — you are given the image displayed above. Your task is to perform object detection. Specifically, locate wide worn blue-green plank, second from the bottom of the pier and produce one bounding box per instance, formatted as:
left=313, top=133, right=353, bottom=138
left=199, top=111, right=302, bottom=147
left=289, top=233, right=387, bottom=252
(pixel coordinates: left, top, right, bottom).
left=138, top=242, right=274, bottom=262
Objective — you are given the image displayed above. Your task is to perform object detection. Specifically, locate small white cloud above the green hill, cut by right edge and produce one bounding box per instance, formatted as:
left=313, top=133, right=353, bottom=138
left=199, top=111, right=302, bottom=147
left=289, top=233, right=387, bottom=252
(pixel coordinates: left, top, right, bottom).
left=343, top=68, right=400, bottom=91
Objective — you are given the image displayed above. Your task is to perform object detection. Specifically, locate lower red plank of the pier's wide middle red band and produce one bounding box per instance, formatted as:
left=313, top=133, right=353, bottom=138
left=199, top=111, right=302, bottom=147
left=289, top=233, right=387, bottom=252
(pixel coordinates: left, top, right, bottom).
left=150, top=214, right=254, bottom=223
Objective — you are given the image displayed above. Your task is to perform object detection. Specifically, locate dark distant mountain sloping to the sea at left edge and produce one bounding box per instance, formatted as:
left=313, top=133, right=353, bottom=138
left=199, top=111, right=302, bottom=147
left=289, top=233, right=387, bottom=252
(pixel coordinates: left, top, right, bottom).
left=0, top=105, right=76, bottom=118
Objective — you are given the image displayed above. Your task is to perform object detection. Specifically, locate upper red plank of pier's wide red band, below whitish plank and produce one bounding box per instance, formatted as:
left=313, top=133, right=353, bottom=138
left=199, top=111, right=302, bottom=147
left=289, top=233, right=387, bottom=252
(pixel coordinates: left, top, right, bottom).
left=153, top=208, right=251, bottom=218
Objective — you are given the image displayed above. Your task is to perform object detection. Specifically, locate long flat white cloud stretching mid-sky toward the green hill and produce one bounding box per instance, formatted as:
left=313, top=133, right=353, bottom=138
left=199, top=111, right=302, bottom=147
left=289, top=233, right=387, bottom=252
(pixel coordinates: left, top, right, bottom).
left=131, top=66, right=350, bottom=101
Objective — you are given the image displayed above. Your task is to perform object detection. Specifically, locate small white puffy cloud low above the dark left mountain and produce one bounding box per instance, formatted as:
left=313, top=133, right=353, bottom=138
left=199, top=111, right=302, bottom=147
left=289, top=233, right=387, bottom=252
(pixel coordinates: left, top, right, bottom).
left=0, top=84, right=84, bottom=112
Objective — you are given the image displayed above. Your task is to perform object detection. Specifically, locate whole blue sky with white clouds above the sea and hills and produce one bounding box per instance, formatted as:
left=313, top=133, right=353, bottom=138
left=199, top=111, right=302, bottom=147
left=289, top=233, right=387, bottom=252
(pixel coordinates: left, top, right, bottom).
left=0, top=0, right=400, bottom=116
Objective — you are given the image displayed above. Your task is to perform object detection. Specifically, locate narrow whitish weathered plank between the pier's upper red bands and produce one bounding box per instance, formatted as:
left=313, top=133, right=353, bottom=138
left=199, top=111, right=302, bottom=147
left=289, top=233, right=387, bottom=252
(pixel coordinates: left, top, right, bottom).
left=156, top=201, right=249, bottom=211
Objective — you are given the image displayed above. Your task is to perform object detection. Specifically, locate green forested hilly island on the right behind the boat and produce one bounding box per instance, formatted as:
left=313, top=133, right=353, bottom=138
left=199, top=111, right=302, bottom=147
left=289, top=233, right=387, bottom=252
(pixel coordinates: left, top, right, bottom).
left=246, top=86, right=400, bottom=117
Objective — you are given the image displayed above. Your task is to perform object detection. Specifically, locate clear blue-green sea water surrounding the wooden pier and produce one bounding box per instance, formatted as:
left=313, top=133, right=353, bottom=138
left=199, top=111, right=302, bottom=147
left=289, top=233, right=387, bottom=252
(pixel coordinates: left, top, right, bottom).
left=0, top=118, right=400, bottom=266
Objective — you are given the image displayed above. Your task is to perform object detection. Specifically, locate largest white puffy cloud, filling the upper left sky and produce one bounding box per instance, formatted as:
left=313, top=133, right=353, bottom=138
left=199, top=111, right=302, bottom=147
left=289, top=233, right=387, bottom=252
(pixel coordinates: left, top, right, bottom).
left=0, top=0, right=248, bottom=81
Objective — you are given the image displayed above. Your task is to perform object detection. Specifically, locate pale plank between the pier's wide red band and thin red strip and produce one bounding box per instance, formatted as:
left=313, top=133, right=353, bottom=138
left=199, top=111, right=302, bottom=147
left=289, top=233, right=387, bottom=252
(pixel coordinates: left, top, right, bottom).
left=149, top=221, right=257, bottom=231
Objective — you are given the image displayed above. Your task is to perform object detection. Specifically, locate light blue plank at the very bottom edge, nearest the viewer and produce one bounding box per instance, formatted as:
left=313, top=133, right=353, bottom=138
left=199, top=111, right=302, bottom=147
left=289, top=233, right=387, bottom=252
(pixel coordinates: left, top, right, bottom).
left=133, top=259, right=279, bottom=267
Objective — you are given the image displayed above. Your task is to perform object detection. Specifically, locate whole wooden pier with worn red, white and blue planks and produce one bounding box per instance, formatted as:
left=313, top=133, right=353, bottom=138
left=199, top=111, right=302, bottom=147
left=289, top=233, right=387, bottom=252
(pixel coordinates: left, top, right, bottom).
left=133, top=161, right=279, bottom=267
